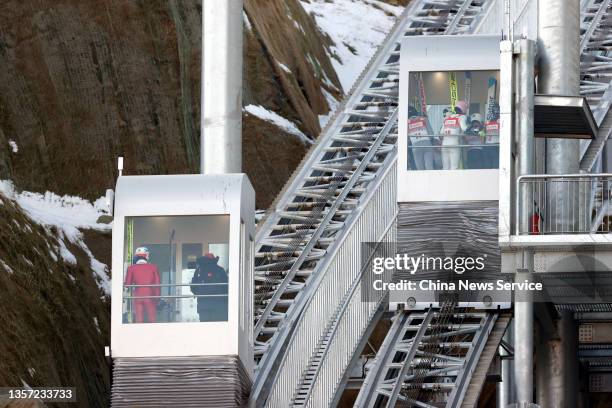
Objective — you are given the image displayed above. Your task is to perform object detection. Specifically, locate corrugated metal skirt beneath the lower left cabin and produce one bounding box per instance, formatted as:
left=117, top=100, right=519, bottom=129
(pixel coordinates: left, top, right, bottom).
left=111, top=356, right=251, bottom=408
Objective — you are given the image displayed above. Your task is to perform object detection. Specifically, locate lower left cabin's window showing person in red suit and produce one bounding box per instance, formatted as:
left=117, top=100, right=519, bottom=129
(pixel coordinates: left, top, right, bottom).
left=123, top=215, right=229, bottom=323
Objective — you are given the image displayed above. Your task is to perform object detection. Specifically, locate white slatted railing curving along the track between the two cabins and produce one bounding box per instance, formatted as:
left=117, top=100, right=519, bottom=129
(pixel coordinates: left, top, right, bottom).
left=266, top=159, right=397, bottom=407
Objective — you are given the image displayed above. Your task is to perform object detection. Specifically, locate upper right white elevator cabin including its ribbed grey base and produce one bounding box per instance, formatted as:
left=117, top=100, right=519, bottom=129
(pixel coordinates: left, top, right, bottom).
left=390, top=35, right=510, bottom=308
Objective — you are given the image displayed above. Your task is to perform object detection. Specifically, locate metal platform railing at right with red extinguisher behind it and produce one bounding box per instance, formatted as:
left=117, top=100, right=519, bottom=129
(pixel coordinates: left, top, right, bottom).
left=516, top=173, right=612, bottom=235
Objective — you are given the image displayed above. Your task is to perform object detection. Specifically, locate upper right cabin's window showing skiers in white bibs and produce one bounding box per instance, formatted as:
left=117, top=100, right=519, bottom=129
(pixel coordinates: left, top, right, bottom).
left=406, top=71, right=499, bottom=170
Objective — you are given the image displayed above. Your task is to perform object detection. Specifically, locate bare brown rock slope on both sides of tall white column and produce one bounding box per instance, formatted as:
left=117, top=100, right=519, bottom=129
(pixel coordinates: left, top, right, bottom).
left=0, top=0, right=340, bottom=202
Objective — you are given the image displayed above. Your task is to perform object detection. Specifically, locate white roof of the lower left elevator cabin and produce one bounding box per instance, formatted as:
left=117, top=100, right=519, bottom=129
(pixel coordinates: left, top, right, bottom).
left=115, top=174, right=252, bottom=216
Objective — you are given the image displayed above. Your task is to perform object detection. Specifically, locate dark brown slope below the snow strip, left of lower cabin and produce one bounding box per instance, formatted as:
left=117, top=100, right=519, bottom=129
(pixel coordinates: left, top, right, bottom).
left=0, top=189, right=110, bottom=407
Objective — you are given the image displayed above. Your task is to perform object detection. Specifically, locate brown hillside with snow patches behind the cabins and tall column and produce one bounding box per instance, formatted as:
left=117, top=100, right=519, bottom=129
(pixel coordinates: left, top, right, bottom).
left=0, top=0, right=406, bottom=407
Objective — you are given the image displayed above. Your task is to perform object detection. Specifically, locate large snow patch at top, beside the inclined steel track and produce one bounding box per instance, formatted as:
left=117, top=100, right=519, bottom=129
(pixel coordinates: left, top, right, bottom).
left=301, top=0, right=404, bottom=93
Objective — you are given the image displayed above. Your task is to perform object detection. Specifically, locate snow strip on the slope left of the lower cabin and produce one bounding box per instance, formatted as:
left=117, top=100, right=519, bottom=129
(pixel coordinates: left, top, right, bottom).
left=0, top=180, right=112, bottom=294
